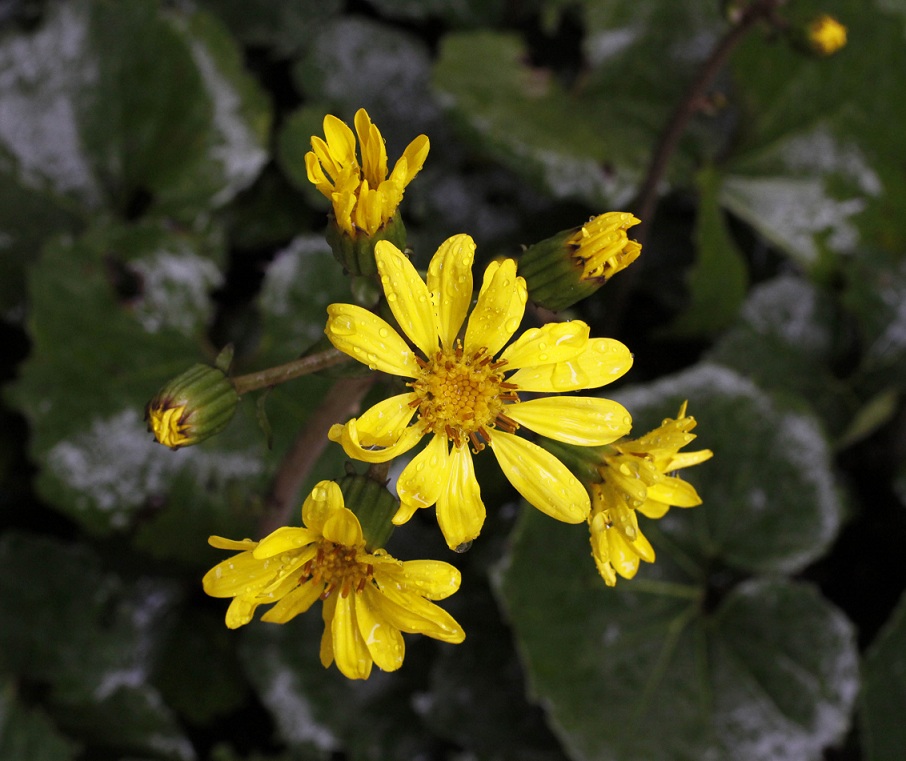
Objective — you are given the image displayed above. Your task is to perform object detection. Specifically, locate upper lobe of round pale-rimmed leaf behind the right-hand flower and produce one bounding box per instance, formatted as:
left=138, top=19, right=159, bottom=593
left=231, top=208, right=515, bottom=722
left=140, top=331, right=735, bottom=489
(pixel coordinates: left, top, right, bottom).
left=614, top=364, right=842, bottom=573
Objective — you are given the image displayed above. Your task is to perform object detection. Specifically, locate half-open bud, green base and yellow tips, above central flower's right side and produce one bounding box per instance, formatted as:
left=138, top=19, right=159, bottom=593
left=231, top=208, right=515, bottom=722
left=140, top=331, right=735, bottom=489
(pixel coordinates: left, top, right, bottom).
left=519, top=211, right=642, bottom=312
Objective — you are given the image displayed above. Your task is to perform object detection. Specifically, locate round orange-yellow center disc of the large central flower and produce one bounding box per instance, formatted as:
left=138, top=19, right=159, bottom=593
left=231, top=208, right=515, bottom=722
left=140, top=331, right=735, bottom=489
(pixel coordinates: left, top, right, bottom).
left=409, top=343, right=519, bottom=452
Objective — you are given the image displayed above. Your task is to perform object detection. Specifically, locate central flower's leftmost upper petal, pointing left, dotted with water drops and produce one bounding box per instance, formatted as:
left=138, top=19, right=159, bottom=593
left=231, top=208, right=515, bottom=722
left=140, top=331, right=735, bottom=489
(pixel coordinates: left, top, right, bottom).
left=324, top=304, right=419, bottom=378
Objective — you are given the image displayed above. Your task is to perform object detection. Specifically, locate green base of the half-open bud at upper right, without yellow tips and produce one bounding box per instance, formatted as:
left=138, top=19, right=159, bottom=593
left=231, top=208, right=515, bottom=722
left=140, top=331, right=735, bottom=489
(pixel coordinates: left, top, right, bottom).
left=519, top=227, right=606, bottom=312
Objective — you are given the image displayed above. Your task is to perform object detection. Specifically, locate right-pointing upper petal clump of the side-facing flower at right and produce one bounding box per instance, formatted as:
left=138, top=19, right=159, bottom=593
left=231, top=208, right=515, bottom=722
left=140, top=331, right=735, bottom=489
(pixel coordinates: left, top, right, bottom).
left=599, top=402, right=714, bottom=518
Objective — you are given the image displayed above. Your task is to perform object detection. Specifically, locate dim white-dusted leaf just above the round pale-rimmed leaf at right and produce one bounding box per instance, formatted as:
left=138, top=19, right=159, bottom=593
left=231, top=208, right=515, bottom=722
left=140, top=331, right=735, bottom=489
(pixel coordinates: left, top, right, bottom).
left=707, top=275, right=858, bottom=433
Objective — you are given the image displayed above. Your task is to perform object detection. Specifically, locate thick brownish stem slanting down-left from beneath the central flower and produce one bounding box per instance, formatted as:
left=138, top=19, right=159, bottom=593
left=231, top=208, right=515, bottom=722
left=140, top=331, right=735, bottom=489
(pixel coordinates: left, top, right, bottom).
left=258, top=375, right=376, bottom=537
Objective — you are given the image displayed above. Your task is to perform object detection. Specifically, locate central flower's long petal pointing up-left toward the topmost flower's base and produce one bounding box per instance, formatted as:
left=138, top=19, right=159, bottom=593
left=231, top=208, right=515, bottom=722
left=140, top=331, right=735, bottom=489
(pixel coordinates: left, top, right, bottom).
left=374, top=240, right=437, bottom=357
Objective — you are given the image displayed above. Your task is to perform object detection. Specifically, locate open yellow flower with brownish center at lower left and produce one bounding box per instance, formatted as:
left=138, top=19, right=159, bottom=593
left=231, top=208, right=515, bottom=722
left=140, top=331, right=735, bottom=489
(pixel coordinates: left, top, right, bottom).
left=203, top=481, right=465, bottom=679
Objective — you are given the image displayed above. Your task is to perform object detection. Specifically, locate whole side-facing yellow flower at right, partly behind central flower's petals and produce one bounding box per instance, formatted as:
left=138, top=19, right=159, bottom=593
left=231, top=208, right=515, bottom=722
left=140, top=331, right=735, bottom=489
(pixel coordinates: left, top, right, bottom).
left=588, top=402, right=713, bottom=586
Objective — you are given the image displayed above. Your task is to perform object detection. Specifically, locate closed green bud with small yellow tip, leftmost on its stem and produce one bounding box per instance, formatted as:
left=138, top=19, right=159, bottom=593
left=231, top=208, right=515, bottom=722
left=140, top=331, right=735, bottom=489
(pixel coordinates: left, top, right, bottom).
left=145, top=364, right=239, bottom=450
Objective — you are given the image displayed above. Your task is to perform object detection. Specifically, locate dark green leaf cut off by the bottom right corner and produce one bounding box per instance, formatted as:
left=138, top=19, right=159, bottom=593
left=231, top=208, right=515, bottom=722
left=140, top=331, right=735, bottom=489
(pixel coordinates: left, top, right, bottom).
left=860, top=596, right=906, bottom=761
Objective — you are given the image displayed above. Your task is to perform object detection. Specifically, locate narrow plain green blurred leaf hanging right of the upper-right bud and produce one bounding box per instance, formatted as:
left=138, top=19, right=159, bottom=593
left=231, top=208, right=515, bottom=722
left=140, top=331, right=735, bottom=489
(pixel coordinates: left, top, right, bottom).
left=668, top=169, right=748, bottom=336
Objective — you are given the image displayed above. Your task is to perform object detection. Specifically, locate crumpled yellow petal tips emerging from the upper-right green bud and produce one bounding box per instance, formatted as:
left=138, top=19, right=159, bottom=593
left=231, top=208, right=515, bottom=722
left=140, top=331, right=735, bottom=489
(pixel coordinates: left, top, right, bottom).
left=567, top=211, right=642, bottom=282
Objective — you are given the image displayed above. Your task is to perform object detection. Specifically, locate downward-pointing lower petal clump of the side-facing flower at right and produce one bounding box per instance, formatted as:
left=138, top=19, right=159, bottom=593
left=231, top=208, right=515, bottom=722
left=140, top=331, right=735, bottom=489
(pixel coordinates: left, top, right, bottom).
left=588, top=496, right=654, bottom=587
